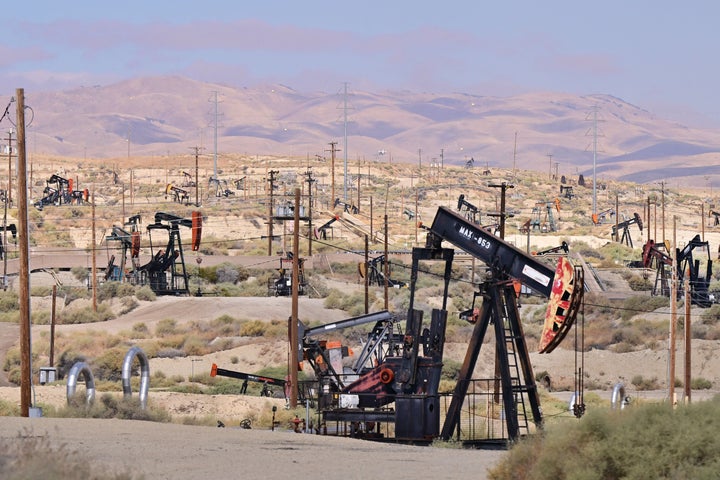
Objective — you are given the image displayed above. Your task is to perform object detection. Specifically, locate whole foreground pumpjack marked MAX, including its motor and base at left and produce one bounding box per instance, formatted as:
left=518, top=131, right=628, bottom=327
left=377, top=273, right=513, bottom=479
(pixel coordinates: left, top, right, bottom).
left=284, top=207, right=584, bottom=444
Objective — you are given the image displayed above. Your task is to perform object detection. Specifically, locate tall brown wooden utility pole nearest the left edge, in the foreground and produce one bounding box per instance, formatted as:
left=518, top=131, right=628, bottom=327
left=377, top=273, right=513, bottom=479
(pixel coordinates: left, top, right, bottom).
left=15, top=88, right=32, bottom=417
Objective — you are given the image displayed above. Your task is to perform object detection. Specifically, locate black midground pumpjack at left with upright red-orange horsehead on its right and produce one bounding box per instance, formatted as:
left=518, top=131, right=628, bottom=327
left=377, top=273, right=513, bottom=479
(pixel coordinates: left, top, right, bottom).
left=138, top=211, right=202, bottom=295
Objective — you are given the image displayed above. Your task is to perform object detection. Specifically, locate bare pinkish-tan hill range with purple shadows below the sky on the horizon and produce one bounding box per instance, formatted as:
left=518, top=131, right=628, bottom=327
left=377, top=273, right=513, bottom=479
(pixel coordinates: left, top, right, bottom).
left=19, top=77, right=720, bottom=183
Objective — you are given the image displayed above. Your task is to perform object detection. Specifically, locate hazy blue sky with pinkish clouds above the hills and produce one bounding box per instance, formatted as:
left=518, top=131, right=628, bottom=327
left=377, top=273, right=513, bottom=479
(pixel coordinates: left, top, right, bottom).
left=0, top=0, right=720, bottom=128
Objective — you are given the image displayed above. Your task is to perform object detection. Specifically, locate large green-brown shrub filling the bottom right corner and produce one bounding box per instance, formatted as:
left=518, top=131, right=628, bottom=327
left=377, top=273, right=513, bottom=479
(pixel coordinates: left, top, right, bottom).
left=488, top=397, right=720, bottom=480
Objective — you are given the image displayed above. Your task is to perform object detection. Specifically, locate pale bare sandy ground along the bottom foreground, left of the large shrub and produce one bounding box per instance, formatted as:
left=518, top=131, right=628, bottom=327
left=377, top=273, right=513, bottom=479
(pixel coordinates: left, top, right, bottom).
left=0, top=417, right=503, bottom=480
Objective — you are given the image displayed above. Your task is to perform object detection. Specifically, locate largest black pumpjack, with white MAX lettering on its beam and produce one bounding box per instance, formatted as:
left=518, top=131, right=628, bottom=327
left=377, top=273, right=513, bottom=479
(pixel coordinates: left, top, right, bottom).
left=310, top=207, right=583, bottom=443
